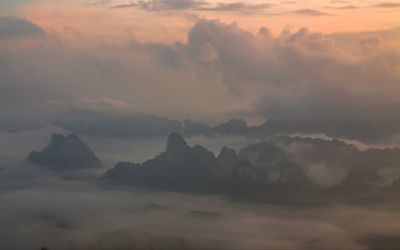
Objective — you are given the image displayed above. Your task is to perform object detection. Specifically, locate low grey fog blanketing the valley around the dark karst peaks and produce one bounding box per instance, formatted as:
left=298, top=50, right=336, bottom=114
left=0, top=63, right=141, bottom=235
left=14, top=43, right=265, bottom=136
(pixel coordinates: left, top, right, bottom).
left=0, top=127, right=400, bottom=250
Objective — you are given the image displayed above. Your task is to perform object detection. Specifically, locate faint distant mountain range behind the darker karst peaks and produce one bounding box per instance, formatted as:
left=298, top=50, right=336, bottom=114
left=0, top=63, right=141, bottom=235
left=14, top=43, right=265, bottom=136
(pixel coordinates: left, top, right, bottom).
left=54, top=113, right=392, bottom=142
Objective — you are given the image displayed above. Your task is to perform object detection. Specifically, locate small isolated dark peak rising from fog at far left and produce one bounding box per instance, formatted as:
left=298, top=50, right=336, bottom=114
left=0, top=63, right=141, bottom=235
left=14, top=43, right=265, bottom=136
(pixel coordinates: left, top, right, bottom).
left=27, top=134, right=101, bottom=170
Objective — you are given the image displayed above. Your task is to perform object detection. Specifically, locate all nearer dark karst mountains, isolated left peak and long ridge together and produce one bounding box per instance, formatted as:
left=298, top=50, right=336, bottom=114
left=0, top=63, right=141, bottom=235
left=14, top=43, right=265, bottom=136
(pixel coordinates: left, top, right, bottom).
left=27, top=132, right=400, bottom=202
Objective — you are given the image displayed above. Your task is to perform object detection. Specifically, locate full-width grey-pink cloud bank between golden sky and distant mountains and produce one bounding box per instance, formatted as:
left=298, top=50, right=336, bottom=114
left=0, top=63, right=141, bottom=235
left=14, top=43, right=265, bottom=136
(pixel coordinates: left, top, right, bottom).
left=0, top=16, right=400, bottom=141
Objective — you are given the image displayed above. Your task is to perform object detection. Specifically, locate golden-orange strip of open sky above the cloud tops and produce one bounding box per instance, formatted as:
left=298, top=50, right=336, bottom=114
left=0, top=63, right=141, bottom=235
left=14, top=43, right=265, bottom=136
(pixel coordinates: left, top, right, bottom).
left=3, top=0, right=400, bottom=41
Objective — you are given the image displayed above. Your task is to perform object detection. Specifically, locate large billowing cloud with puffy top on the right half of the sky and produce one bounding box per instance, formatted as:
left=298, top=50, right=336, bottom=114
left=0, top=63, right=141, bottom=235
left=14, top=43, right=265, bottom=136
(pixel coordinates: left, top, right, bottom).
left=138, top=20, right=400, bottom=143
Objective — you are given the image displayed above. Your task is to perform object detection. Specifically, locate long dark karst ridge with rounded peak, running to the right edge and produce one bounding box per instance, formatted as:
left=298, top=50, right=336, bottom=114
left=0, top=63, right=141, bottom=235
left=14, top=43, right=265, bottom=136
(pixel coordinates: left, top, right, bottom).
left=103, top=133, right=400, bottom=200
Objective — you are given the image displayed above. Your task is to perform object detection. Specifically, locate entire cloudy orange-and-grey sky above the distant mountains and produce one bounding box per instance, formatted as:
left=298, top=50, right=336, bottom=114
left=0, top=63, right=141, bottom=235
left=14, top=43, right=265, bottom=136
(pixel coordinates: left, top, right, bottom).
left=0, top=0, right=400, bottom=139
